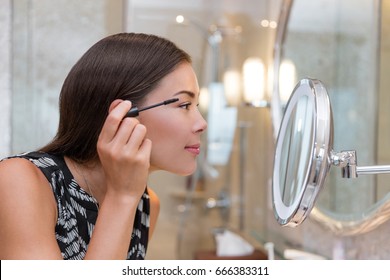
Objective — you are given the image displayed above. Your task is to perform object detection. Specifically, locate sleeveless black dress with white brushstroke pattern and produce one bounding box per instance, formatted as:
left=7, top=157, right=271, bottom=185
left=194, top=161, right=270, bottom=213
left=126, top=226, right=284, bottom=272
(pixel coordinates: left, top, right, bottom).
left=1, top=152, right=150, bottom=260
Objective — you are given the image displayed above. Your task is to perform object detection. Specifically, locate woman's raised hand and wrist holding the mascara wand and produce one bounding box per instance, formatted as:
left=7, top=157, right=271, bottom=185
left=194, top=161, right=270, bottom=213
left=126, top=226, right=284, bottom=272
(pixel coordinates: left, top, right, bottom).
left=97, top=100, right=152, bottom=199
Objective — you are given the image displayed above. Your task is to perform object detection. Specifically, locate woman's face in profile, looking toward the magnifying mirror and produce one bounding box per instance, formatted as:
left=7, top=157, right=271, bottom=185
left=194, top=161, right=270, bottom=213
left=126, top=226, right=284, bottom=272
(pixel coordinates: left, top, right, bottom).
left=139, top=63, right=207, bottom=175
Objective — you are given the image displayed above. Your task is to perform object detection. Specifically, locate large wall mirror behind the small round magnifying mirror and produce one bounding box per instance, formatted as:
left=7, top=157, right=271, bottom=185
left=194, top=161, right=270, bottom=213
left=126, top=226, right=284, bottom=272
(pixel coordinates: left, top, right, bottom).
left=273, top=0, right=390, bottom=234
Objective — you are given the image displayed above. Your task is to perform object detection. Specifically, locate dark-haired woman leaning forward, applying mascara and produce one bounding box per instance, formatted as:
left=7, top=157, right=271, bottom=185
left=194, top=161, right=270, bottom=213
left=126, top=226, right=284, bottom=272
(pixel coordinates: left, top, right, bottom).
left=0, top=33, right=207, bottom=259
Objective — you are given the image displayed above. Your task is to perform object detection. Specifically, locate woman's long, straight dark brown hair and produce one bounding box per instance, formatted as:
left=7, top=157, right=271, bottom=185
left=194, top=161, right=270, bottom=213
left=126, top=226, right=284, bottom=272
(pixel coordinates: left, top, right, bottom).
left=40, top=33, right=191, bottom=162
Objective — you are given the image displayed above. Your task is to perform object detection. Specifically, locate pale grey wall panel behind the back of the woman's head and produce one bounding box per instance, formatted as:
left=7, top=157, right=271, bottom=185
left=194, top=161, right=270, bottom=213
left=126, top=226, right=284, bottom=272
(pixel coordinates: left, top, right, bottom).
left=10, top=0, right=122, bottom=153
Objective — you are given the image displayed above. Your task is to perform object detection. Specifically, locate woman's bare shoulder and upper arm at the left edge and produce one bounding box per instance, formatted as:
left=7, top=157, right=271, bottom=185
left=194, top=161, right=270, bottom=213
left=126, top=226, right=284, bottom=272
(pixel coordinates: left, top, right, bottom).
left=0, top=158, right=61, bottom=259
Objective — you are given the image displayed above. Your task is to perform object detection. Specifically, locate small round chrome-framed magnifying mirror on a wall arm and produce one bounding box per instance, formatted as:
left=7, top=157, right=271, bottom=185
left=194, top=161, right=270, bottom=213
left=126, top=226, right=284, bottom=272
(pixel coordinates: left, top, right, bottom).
left=272, top=78, right=333, bottom=227
